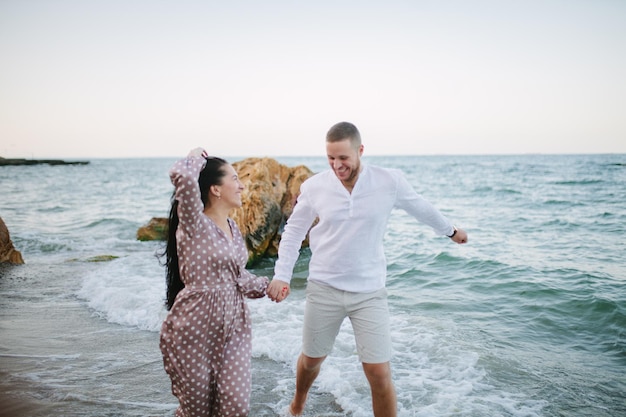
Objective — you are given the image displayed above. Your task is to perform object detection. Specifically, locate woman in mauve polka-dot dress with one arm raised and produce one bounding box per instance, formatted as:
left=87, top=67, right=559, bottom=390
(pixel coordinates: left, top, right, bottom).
left=160, top=148, right=268, bottom=417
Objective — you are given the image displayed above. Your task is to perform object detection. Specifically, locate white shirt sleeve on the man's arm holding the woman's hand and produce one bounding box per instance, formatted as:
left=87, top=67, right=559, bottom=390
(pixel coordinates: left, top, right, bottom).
left=274, top=183, right=317, bottom=282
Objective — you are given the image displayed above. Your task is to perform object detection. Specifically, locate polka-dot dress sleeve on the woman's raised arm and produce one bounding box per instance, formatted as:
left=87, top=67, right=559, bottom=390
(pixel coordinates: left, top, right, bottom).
left=169, top=157, right=206, bottom=236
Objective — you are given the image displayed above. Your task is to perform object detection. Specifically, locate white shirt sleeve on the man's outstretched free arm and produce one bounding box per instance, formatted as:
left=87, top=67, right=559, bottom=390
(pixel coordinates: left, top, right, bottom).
left=396, top=171, right=454, bottom=236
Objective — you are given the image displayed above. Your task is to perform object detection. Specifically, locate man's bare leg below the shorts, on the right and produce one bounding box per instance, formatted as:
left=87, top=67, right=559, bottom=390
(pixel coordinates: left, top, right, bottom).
left=363, top=362, right=398, bottom=417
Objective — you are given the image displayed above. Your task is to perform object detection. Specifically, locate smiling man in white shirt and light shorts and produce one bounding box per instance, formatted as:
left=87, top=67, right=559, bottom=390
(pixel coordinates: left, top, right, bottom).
left=267, top=122, right=467, bottom=417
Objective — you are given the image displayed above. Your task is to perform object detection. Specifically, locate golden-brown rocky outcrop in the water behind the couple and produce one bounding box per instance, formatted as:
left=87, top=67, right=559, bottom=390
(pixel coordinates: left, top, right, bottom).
left=137, top=158, right=313, bottom=264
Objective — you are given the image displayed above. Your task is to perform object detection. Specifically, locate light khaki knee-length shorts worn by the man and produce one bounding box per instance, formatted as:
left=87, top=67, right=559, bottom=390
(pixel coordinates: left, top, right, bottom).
left=302, top=281, right=391, bottom=363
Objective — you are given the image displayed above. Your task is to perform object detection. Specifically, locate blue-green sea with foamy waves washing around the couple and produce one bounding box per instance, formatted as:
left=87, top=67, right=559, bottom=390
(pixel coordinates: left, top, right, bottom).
left=0, top=154, right=626, bottom=417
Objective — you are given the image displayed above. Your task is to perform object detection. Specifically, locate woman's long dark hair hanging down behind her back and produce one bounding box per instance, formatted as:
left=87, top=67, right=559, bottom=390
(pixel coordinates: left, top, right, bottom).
left=160, top=157, right=228, bottom=310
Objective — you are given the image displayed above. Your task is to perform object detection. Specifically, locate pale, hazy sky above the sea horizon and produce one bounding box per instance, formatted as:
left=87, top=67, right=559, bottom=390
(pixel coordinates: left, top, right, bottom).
left=0, top=0, right=626, bottom=159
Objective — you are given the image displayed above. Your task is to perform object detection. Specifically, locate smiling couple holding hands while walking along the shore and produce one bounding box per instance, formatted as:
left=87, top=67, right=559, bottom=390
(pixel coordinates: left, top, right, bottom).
left=160, top=122, right=467, bottom=417
